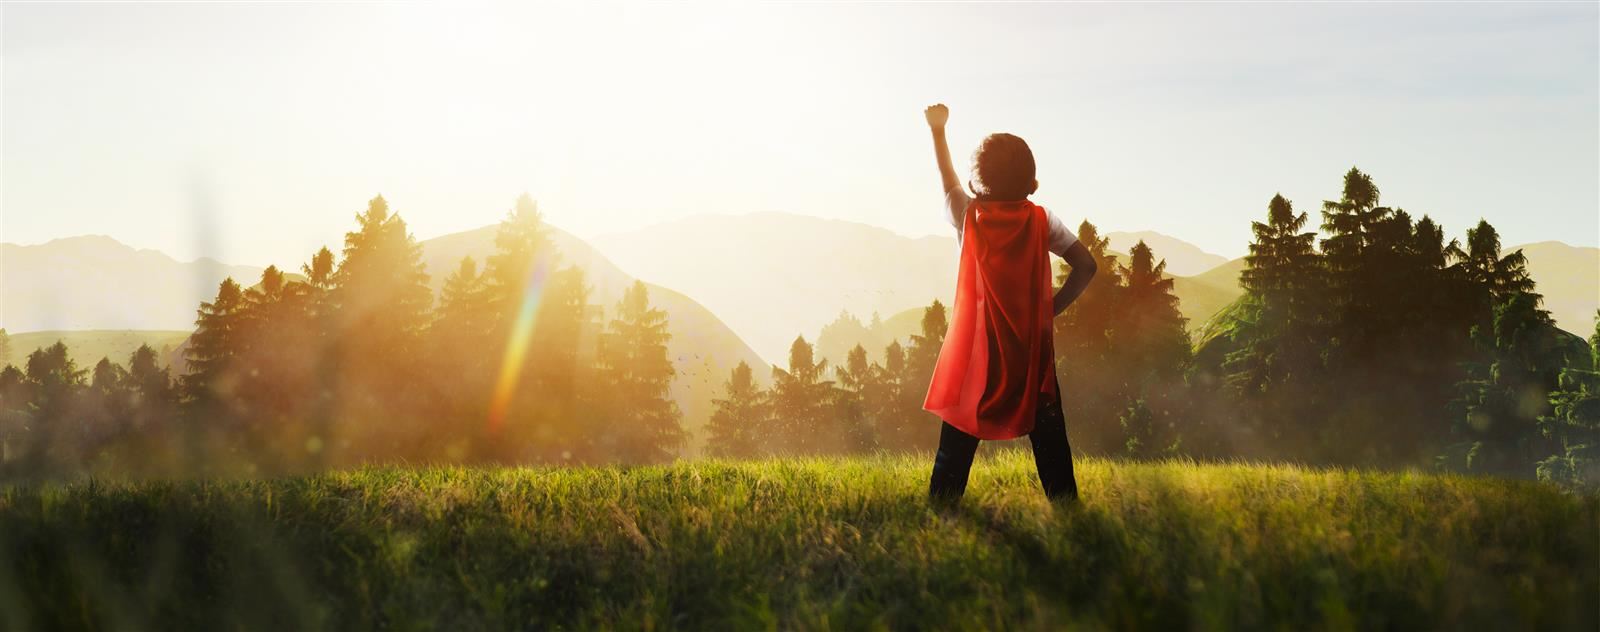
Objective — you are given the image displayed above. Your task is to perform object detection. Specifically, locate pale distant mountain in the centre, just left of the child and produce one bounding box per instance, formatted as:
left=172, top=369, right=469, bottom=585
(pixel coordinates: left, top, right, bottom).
left=590, top=213, right=957, bottom=363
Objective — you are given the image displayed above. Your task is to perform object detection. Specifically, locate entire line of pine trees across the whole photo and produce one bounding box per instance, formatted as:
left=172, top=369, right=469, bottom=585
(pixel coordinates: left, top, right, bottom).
left=0, top=168, right=1600, bottom=483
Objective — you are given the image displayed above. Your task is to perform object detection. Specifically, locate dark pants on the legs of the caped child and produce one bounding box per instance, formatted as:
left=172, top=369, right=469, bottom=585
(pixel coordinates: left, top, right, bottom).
left=928, top=398, right=1078, bottom=501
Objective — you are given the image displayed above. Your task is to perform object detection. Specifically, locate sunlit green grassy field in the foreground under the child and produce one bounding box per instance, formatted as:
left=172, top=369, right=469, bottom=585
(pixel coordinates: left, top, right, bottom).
left=0, top=451, right=1600, bottom=630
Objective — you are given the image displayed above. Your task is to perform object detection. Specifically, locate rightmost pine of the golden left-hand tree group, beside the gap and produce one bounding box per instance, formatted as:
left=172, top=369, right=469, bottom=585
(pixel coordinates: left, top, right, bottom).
left=592, top=282, right=683, bottom=462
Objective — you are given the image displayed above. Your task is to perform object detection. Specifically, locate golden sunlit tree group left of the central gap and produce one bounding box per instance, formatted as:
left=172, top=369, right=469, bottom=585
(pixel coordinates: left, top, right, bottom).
left=0, top=195, right=685, bottom=477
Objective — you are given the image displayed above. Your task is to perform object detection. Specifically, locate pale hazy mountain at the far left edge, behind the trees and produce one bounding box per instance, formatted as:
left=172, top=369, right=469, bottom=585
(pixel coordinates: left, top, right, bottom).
left=0, top=235, right=261, bottom=333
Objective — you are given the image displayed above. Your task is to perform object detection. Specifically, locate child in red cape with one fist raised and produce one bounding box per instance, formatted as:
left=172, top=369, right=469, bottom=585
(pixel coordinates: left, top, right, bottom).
left=923, top=104, right=1096, bottom=502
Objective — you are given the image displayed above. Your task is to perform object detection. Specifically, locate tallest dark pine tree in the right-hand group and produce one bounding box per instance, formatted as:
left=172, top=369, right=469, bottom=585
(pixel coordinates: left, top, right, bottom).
left=1306, top=168, right=1466, bottom=464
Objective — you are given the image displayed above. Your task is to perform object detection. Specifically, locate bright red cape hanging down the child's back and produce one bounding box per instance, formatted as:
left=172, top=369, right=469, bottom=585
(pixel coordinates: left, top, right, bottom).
left=922, top=200, right=1056, bottom=440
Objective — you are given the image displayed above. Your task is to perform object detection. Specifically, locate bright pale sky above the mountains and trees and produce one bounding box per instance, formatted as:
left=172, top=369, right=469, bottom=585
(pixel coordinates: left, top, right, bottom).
left=0, top=2, right=1600, bottom=267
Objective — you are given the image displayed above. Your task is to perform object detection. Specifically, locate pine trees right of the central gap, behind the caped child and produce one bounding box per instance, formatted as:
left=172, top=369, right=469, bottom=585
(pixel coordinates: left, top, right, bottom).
left=709, top=168, right=1600, bottom=485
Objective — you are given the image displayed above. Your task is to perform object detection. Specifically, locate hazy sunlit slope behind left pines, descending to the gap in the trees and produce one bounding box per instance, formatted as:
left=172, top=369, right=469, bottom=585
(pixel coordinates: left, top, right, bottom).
left=422, top=226, right=771, bottom=454
